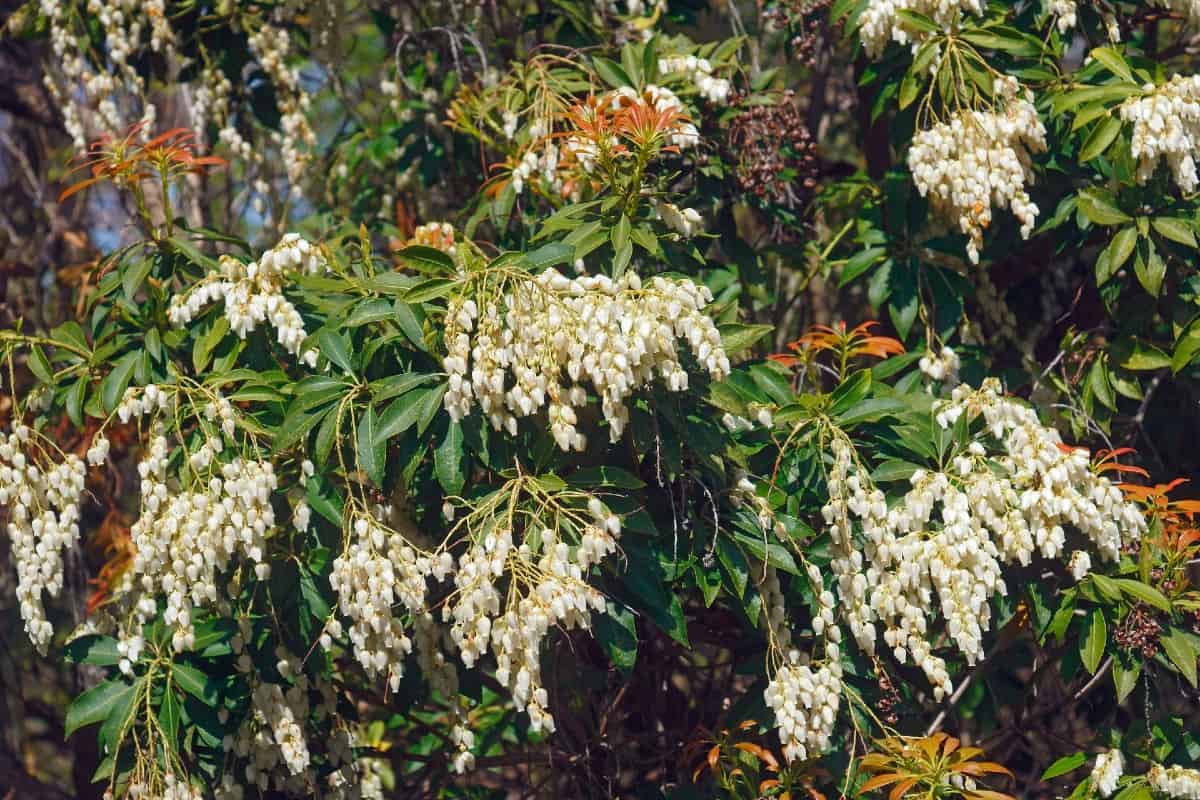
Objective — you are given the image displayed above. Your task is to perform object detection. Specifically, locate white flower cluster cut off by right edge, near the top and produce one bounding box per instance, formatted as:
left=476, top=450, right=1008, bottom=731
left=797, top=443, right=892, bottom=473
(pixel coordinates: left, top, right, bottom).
left=1121, top=76, right=1200, bottom=193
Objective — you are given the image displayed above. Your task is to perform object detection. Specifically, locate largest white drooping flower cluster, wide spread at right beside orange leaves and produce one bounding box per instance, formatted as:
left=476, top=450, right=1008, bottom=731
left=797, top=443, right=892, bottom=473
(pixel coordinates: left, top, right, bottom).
left=822, top=379, right=1146, bottom=698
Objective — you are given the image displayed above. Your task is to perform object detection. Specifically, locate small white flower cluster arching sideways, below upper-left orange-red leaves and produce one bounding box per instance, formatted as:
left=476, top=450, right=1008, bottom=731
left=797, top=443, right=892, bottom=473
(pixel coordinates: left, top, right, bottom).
left=167, top=234, right=328, bottom=367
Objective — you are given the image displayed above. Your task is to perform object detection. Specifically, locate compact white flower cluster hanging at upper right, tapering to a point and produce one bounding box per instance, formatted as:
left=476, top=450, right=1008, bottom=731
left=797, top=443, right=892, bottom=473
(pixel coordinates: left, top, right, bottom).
left=908, top=78, right=1046, bottom=263
